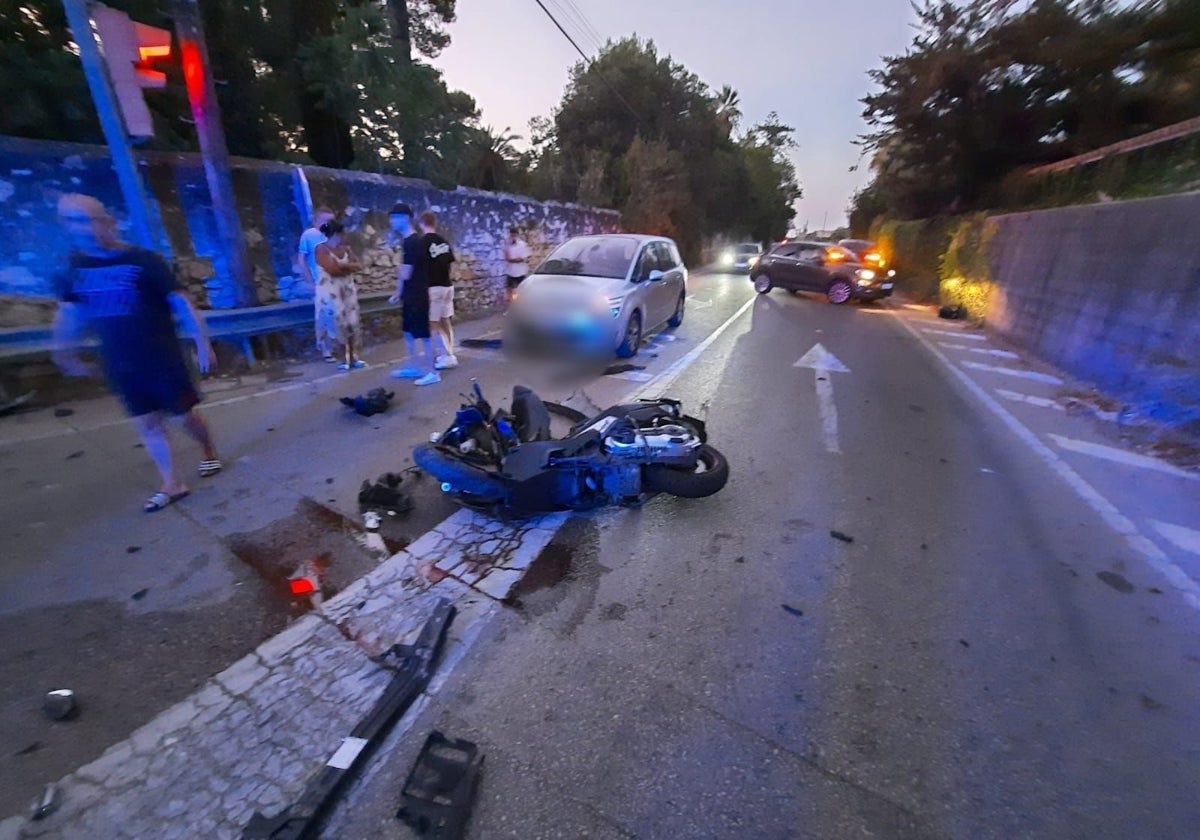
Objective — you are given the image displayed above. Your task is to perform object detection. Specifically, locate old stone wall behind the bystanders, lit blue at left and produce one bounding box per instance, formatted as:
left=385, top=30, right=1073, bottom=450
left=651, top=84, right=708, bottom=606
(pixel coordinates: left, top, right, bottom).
left=0, top=137, right=620, bottom=326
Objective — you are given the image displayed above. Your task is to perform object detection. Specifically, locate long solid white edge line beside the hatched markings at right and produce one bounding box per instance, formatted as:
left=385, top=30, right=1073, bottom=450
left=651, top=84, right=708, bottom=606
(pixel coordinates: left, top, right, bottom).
left=896, top=316, right=1200, bottom=611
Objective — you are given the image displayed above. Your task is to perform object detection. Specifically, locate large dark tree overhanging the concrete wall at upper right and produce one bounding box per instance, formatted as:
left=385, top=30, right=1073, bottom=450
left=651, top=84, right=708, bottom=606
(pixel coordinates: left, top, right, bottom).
left=856, top=0, right=1200, bottom=223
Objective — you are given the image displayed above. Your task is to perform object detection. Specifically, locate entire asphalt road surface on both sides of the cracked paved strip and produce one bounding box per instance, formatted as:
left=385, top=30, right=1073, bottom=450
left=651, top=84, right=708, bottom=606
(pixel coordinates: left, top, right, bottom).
left=0, top=275, right=1200, bottom=839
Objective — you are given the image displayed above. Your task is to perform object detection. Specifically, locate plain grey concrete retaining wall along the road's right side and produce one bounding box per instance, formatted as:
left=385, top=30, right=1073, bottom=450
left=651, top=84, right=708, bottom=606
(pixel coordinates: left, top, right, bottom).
left=988, top=193, right=1200, bottom=432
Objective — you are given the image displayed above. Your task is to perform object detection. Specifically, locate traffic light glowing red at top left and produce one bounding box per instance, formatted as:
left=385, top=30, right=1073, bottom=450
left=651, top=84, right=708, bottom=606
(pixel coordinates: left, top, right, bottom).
left=91, top=2, right=170, bottom=137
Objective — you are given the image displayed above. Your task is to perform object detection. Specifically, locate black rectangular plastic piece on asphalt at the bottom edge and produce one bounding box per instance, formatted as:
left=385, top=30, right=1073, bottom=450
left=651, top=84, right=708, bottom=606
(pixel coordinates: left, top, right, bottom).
left=396, top=730, right=484, bottom=840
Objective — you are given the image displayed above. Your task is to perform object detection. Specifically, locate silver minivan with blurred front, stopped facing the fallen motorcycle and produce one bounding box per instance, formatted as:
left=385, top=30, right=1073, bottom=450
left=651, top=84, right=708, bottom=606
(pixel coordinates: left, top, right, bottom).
left=504, top=234, right=688, bottom=359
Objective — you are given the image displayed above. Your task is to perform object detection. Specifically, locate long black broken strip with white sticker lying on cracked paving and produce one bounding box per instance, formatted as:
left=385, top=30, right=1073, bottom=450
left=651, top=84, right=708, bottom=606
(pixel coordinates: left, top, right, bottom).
left=241, top=599, right=455, bottom=840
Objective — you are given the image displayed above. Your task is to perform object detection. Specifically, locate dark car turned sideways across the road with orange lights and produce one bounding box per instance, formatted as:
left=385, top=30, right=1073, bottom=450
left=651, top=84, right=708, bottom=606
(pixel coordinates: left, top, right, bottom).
left=750, top=241, right=894, bottom=304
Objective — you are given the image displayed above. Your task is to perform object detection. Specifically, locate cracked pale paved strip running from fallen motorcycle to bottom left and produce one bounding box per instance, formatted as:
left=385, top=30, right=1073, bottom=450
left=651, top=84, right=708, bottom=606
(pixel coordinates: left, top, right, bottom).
left=11, top=510, right=566, bottom=840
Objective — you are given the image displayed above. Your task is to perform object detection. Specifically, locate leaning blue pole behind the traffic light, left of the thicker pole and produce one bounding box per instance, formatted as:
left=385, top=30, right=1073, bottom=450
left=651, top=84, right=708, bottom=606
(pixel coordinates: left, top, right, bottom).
left=62, top=0, right=170, bottom=253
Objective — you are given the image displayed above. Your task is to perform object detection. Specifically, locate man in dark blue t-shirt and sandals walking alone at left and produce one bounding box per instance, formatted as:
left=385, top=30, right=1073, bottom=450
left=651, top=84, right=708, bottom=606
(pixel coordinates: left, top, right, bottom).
left=54, top=194, right=221, bottom=512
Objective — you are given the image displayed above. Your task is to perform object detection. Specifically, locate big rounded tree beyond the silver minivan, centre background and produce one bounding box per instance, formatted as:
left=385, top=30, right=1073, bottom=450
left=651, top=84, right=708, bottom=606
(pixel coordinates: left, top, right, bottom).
left=529, top=36, right=799, bottom=257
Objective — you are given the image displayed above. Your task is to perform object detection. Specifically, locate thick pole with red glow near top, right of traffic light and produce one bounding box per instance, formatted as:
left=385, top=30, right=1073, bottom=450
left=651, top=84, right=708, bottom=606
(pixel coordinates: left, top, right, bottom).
left=172, top=0, right=258, bottom=306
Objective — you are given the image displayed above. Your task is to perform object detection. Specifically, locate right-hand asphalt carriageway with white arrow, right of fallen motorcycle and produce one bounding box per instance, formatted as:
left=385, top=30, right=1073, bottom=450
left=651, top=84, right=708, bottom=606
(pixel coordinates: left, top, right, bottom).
left=325, top=278, right=1200, bottom=840
